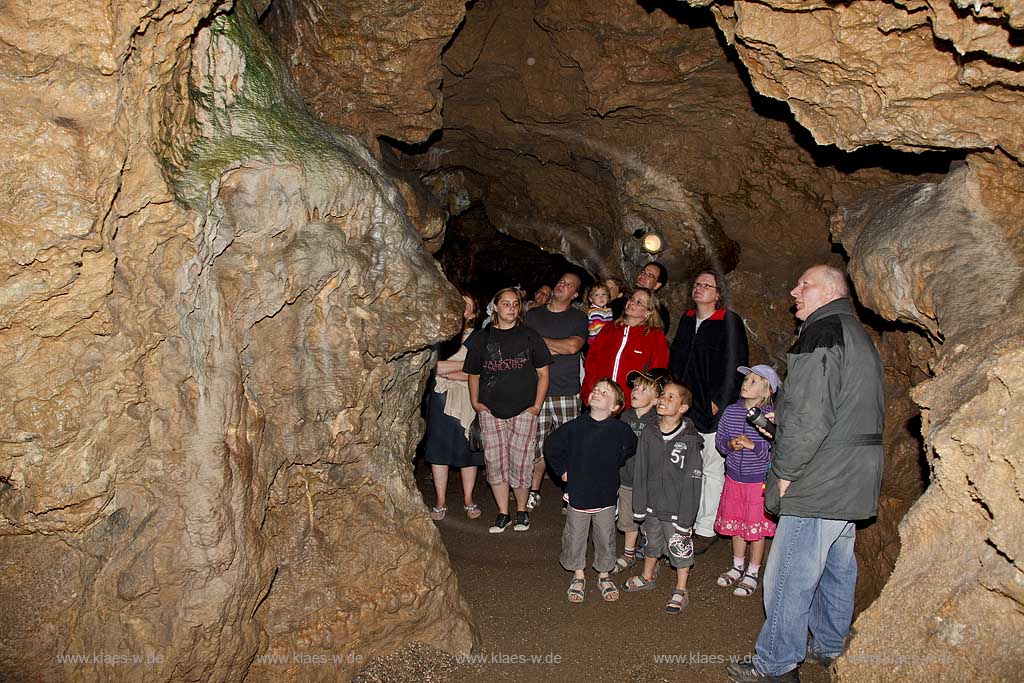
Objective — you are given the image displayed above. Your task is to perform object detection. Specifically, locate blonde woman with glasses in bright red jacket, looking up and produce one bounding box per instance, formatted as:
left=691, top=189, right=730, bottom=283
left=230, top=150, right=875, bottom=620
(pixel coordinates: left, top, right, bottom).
left=580, top=287, right=669, bottom=407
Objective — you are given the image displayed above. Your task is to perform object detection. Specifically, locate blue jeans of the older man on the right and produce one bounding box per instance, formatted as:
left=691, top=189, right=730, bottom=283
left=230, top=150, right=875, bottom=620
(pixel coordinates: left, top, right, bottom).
left=754, top=515, right=857, bottom=676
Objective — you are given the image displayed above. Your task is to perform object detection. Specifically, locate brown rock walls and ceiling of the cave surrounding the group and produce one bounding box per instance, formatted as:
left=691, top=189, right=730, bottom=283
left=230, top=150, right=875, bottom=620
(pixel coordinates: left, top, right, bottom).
left=0, top=0, right=1024, bottom=681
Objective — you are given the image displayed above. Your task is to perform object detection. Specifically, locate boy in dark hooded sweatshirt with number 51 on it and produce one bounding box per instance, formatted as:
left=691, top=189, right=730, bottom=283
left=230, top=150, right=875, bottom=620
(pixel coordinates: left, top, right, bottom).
left=623, top=380, right=703, bottom=614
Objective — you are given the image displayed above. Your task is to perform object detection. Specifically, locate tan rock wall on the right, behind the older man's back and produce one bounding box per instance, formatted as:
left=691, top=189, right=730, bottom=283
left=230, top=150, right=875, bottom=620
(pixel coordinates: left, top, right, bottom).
left=834, top=156, right=1024, bottom=681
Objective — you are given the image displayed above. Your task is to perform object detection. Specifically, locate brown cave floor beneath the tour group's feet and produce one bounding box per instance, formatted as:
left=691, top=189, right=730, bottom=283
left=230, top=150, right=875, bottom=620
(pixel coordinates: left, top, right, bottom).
left=353, top=462, right=829, bottom=683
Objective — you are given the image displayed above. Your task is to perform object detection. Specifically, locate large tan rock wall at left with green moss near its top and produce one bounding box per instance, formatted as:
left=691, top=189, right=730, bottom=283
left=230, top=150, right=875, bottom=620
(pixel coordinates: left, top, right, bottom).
left=0, top=0, right=474, bottom=681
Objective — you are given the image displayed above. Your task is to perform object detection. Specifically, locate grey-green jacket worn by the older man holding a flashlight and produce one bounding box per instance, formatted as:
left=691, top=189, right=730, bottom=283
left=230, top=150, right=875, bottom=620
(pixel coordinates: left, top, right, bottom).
left=765, top=298, right=885, bottom=521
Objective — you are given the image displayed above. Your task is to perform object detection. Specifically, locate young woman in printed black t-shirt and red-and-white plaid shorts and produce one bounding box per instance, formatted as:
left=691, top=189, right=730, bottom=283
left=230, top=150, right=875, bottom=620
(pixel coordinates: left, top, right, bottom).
left=463, top=288, right=552, bottom=533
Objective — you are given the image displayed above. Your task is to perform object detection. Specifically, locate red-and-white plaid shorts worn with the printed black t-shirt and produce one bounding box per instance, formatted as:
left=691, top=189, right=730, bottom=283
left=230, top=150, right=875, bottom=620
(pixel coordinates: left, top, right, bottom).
left=478, top=411, right=538, bottom=488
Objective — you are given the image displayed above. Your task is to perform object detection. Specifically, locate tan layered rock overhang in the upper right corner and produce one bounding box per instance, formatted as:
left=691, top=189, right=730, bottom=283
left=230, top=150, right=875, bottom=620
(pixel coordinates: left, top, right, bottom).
left=690, top=0, right=1024, bottom=160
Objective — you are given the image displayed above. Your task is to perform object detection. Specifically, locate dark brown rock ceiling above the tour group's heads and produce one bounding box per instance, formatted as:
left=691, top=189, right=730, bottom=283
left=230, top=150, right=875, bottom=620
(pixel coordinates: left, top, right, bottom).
left=271, top=0, right=962, bottom=294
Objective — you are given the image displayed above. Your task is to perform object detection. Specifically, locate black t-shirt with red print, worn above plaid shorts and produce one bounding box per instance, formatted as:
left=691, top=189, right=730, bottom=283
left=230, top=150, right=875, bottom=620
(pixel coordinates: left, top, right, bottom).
left=462, top=325, right=551, bottom=420
